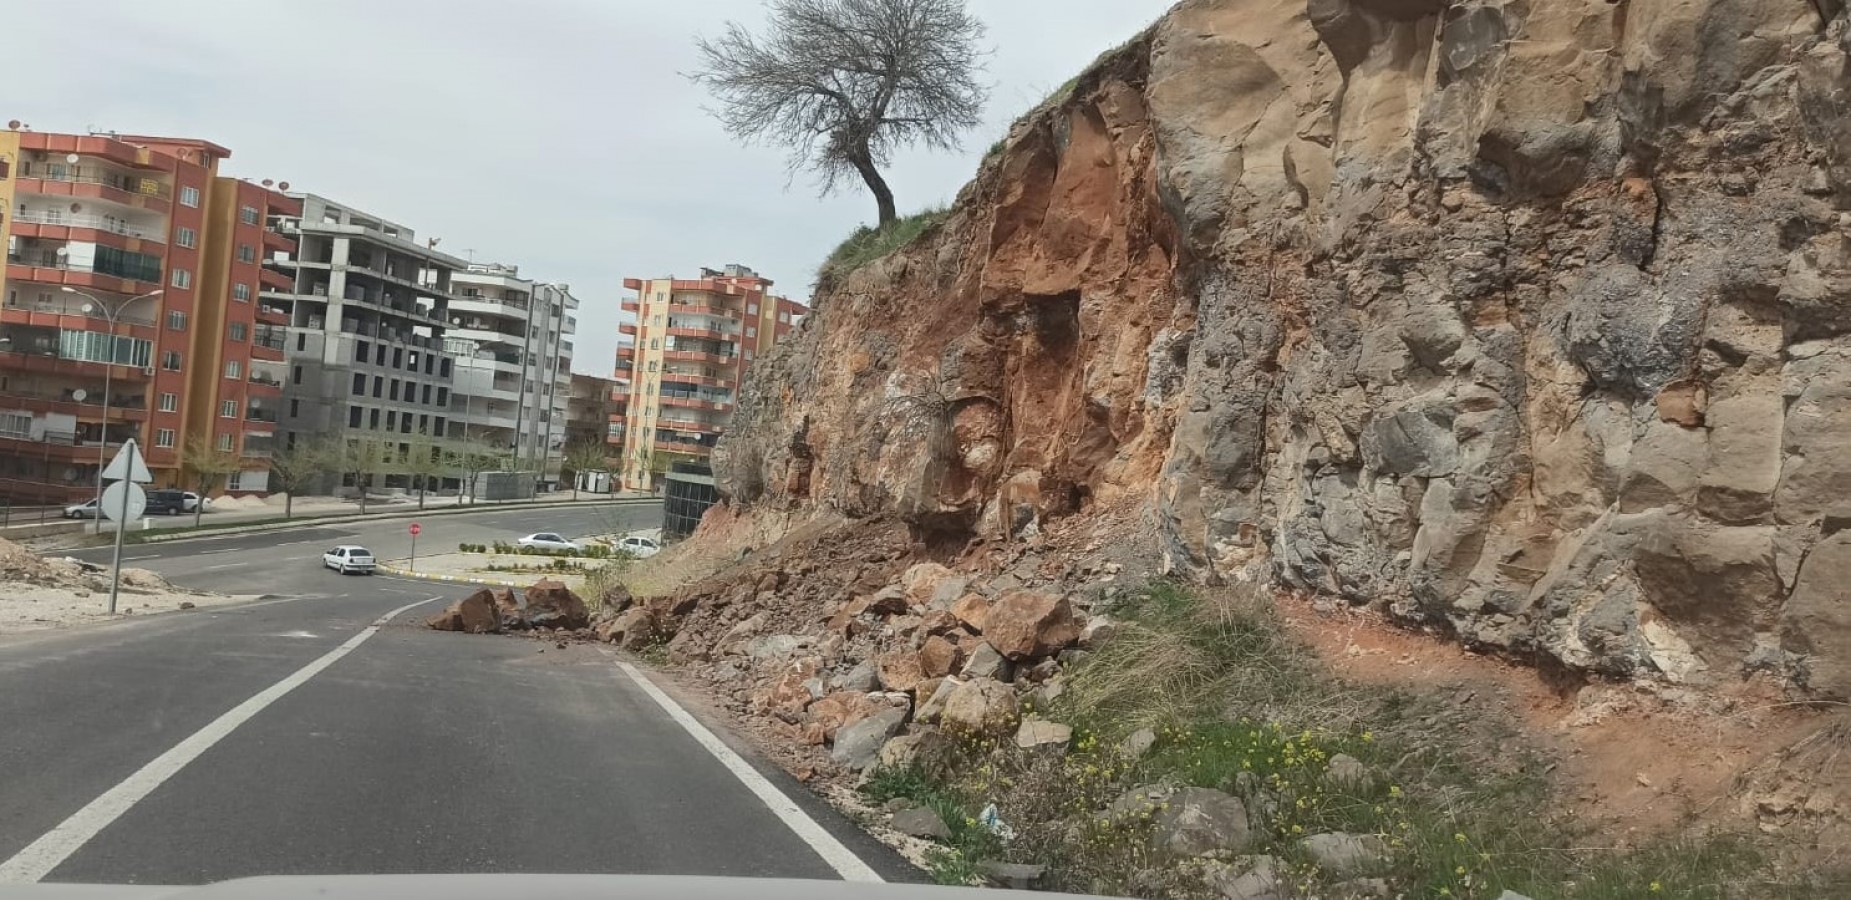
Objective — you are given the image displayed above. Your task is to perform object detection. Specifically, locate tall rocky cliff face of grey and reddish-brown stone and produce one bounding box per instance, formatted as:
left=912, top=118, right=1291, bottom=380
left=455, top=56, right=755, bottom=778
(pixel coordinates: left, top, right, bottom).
left=716, top=0, right=1851, bottom=698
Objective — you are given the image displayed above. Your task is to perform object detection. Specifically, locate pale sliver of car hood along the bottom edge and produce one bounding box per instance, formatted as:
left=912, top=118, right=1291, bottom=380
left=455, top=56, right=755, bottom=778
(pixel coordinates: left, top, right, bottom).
left=0, top=874, right=1075, bottom=900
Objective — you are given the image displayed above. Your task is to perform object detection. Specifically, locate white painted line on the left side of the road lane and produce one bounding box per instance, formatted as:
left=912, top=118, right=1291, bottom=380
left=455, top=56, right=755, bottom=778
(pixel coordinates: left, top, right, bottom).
left=0, top=596, right=441, bottom=883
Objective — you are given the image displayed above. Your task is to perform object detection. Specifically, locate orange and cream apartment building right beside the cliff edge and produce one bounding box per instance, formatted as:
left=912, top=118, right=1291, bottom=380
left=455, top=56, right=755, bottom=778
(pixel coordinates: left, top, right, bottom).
left=609, top=265, right=803, bottom=489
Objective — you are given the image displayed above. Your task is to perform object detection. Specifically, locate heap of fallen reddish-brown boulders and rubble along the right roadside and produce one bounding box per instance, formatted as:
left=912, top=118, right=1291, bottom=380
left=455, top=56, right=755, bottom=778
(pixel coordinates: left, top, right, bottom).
left=592, top=524, right=1112, bottom=772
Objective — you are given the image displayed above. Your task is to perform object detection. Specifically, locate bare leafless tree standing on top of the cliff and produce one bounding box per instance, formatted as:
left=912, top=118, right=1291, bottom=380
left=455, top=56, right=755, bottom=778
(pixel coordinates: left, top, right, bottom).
left=694, top=0, right=988, bottom=228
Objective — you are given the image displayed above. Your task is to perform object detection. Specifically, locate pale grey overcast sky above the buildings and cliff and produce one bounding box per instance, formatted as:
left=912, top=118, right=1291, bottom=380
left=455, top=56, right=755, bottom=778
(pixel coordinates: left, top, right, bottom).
left=0, top=0, right=1170, bottom=376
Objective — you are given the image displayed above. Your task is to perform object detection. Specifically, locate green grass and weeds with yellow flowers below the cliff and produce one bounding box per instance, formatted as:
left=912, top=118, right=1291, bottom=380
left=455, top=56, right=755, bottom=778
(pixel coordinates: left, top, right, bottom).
left=866, top=583, right=1820, bottom=900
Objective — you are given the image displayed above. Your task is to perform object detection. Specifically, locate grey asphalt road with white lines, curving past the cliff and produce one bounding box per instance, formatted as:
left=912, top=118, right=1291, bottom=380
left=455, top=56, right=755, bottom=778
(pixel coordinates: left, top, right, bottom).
left=0, top=507, right=918, bottom=883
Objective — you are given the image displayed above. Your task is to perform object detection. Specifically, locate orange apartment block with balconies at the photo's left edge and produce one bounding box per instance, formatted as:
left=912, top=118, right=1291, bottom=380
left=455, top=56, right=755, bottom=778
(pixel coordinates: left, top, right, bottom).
left=0, top=128, right=231, bottom=504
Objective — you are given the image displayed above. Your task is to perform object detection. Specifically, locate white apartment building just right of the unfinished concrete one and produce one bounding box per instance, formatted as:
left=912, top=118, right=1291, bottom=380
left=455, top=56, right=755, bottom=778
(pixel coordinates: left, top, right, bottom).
left=444, top=263, right=578, bottom=487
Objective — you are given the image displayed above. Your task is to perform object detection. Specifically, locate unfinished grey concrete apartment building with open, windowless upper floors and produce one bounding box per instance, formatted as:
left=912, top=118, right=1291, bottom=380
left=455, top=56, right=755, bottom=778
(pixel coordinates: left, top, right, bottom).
left=257, top=194, right=468, bottom=489
